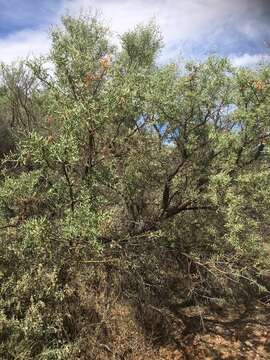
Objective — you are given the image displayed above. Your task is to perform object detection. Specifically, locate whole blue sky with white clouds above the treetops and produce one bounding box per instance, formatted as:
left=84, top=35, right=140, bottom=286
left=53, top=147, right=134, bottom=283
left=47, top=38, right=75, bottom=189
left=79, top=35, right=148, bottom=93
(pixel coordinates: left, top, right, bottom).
left=0, top=0, right=270, bottom=66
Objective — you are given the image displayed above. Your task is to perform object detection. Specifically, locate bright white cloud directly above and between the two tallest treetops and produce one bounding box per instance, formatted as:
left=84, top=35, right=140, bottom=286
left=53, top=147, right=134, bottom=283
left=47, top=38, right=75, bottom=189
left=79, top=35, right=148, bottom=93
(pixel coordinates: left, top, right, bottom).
left=62, top=0, right=226, bottom=44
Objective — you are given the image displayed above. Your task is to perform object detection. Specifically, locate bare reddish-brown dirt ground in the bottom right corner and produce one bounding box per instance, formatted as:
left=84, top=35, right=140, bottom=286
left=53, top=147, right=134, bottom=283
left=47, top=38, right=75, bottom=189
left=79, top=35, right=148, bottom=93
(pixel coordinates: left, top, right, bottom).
left=157, top=306, right=270, bottom=360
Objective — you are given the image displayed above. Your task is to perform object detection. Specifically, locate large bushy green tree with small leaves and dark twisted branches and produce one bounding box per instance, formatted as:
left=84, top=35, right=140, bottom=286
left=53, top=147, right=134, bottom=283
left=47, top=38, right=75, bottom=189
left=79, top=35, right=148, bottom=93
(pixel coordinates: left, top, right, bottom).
left=0, top=12, right=270, bottom=359
